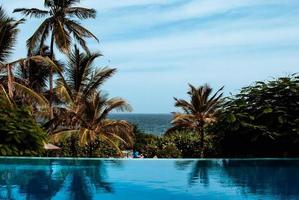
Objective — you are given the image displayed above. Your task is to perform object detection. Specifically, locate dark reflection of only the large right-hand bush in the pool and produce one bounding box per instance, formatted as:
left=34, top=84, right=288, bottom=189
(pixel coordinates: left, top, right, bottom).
left=223, top=160, right=299, bottom=199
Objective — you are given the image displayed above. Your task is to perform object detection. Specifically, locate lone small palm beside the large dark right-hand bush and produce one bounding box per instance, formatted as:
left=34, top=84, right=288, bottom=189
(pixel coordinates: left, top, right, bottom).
left=167, top=84, right=223, bottom=158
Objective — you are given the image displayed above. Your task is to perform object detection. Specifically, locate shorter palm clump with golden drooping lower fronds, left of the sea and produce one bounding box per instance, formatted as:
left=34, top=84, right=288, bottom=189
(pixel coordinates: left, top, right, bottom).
left=48, top=47, right=133, bottom=156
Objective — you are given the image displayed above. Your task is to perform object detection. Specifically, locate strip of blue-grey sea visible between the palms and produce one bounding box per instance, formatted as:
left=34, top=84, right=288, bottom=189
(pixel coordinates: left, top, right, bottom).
left=110, top=114, right=172, bottom=135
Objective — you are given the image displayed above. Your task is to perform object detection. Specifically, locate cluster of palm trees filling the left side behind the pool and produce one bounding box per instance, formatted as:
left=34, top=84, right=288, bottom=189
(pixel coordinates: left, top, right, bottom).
left=0, top=0, right=133, bottom=156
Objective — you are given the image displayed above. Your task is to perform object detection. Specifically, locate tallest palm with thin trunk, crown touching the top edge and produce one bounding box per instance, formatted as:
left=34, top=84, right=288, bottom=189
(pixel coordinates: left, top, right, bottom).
left=14, top=0, right=98, bottom=117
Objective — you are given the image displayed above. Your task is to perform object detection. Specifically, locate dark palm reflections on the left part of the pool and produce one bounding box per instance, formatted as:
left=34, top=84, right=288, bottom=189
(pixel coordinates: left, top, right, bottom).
left=0, top=160, right=119, bottom=200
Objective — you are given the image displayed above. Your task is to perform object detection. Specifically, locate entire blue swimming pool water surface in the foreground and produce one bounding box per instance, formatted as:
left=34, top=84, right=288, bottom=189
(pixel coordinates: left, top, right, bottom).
left=0, top=158, right=299, bottom=200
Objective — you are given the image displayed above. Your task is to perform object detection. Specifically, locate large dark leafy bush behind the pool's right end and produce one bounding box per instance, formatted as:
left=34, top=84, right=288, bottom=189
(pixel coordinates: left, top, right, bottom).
left=212, top=75, right=299, bottom=157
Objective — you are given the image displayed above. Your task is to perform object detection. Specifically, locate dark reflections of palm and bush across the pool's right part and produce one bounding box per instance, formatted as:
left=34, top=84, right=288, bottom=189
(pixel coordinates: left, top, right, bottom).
left=175, top=159, right=299, bottom=199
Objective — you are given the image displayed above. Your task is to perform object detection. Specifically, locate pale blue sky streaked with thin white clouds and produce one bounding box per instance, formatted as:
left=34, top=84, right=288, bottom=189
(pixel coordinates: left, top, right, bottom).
left=0, top=0, right=299, bottom=113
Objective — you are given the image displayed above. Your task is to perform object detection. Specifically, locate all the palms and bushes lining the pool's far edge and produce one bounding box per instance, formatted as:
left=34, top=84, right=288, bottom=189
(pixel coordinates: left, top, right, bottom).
left=0, top=0, right=299, bottom=159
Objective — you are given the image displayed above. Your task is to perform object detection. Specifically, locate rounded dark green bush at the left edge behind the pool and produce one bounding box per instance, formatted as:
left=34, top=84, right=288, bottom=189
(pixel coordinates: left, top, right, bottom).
left=0, top=99, right=46, bottom=156
